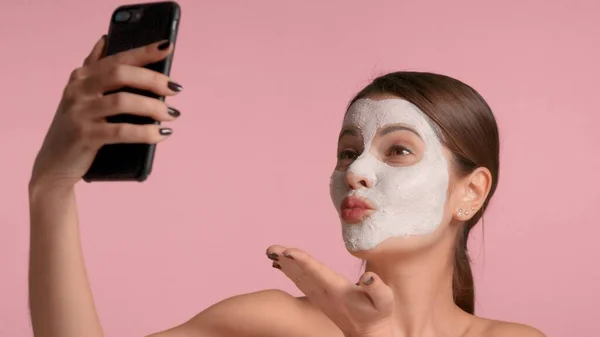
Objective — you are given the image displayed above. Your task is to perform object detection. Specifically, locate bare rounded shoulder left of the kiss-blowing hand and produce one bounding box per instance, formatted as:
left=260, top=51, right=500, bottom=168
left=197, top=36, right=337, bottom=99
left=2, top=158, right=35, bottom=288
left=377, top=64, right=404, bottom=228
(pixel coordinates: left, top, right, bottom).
left=151, top=289, right=339, bottom=337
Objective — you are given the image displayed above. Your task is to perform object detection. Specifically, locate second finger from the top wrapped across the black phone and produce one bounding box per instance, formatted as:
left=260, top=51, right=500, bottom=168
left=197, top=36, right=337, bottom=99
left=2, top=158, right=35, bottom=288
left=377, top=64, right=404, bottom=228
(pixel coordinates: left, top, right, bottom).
left=82, top=64, right=182, bottom=96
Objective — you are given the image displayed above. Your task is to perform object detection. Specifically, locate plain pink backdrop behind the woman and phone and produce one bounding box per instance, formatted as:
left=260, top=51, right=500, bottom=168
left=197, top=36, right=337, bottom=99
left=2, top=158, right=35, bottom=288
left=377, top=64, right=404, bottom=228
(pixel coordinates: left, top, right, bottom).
left=0, top=0, right=600, bottom=337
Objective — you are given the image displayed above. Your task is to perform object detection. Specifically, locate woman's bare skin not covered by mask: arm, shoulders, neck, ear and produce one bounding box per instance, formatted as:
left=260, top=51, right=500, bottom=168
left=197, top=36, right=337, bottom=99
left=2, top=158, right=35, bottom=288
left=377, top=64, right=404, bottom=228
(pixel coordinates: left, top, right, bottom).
left=29, top=39, right=544, bottom=337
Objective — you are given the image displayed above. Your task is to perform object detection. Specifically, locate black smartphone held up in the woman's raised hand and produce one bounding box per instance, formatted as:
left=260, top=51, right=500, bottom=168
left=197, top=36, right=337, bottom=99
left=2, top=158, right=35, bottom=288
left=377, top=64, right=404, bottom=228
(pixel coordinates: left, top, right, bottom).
left=83, top=1, right=181, bottom=182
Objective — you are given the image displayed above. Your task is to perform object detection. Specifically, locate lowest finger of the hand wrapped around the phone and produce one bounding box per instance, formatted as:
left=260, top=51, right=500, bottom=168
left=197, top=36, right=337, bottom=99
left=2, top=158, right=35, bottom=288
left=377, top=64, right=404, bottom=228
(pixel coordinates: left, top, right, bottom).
left=89, top=123, right=173, bottom=145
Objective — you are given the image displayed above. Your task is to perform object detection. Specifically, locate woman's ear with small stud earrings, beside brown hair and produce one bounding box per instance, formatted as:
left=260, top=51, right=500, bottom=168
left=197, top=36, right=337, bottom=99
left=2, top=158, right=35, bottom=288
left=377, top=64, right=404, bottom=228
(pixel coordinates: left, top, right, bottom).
left=453, top=167, right=492, bottom=221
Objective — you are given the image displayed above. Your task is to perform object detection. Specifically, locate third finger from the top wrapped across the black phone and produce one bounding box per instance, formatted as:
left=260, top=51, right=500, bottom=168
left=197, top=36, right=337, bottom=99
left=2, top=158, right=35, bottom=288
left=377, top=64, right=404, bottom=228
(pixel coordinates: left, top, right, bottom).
left=89, top=92, right=181, bottom=121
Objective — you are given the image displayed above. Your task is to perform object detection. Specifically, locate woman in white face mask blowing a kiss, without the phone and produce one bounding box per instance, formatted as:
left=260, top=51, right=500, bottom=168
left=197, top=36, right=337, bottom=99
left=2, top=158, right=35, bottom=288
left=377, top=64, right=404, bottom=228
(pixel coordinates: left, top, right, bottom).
left=29, top=39, right=543, bottom=337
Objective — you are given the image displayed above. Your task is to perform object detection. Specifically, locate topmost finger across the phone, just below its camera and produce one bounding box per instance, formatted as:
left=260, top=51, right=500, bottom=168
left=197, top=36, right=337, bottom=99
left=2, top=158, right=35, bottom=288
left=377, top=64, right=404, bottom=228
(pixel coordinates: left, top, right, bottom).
left=94, top=40, right=173, bottom=69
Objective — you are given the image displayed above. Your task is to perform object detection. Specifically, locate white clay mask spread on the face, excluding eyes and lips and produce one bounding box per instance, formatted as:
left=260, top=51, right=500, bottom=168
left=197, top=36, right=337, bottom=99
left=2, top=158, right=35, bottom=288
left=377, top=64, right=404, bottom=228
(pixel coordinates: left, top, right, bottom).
left=330, top=99, right=449, bottom=251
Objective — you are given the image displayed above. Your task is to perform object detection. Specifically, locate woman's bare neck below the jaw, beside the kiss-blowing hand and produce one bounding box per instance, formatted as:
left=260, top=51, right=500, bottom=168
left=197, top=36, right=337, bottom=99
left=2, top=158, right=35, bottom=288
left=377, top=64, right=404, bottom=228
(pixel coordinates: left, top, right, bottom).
left=366, top=236, right=469, bottom=337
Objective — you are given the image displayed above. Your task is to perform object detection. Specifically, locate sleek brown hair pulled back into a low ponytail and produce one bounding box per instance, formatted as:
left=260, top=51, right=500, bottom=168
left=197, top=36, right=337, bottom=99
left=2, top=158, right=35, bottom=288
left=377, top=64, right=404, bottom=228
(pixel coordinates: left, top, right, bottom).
left=350, top=71, right=500, bottom=314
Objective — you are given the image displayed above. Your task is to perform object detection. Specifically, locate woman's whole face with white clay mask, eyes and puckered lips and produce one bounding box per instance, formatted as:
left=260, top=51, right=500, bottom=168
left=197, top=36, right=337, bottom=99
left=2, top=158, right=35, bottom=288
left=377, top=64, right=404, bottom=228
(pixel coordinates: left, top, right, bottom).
left=331, top=97, right=450, bottom=251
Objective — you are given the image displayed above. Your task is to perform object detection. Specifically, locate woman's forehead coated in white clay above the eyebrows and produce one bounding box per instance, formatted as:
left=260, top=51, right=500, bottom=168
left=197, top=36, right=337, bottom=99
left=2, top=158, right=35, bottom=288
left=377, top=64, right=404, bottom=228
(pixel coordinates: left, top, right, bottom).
left=343, top=98, right=433, bottom=138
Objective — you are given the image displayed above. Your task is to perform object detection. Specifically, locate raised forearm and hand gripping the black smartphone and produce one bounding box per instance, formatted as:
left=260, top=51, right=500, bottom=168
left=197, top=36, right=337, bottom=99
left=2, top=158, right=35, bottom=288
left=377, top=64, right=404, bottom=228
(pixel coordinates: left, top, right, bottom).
left=29, top=39, right=180, bottom=337
